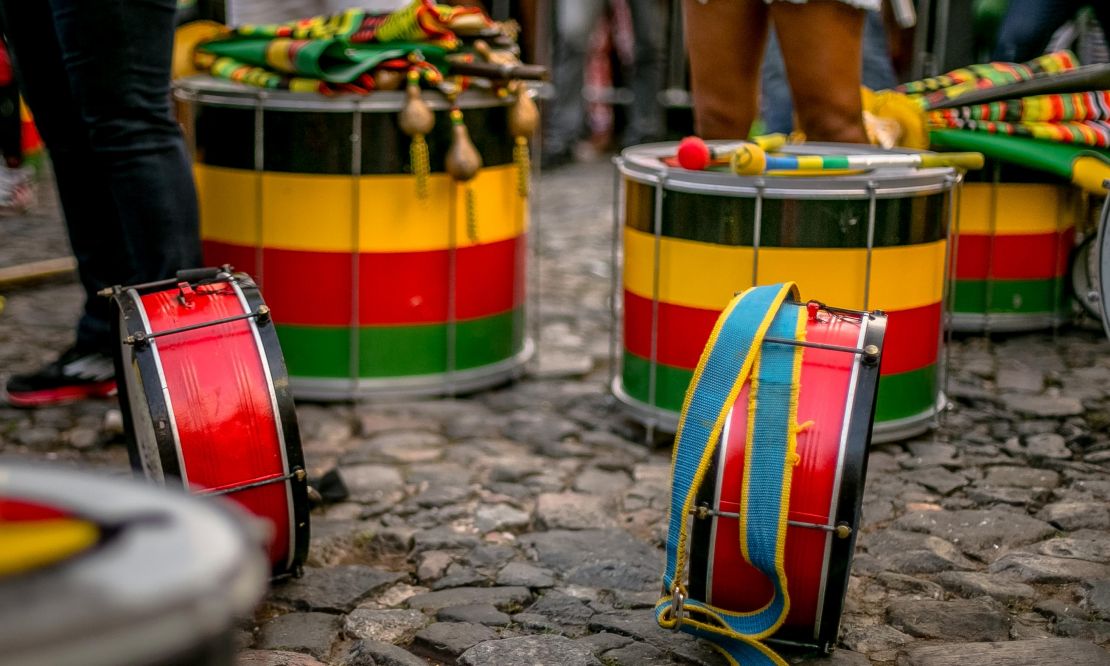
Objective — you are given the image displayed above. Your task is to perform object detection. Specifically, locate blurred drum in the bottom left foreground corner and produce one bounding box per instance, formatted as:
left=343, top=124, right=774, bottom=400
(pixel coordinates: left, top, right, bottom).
left=0, top=463, right=266, bottom=666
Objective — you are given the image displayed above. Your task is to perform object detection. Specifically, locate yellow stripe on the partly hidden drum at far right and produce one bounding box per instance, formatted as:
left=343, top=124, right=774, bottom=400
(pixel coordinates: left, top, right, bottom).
left=959, top=183, right=1076, bottom=235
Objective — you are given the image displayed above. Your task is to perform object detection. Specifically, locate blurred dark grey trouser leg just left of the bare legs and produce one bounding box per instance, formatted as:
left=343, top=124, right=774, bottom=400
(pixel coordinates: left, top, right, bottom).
left=623, top=0, right=667, bottom=145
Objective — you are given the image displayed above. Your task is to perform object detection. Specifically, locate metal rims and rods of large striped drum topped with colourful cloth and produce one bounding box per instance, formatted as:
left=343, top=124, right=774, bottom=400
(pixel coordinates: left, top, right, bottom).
left=173, top=77, right=538, bottom=401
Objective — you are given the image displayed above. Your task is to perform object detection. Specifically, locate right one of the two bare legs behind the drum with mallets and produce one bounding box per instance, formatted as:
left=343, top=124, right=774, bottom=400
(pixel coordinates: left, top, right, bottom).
left=770, top=0, right=867, bottom=143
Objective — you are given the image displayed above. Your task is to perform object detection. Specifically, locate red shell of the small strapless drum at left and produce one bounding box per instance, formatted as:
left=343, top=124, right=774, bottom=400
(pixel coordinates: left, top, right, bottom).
left=142, top=285, right=292, bottom=563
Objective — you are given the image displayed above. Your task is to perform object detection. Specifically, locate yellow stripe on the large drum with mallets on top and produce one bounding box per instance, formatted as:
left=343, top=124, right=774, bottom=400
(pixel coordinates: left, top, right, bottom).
left=624, top=228, right=946, bottom=310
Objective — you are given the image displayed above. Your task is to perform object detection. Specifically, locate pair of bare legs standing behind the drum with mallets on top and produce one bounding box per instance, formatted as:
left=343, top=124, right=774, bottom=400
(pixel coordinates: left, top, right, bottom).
left=684, top=0, right=879, bottom=143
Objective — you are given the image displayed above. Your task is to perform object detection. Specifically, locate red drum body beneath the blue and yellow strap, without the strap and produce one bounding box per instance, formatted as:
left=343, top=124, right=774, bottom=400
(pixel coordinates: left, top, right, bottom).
left=688, top=304, right=887, bottom=652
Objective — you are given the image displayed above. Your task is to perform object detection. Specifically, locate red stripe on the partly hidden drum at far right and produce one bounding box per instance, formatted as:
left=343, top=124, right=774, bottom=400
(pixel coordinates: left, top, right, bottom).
left=955, top=229, right=1076, bottom=280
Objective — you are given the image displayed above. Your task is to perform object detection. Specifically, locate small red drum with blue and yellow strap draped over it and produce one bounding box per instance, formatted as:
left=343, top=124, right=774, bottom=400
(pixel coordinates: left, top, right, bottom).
left=648, top=285, right=887, bottom=664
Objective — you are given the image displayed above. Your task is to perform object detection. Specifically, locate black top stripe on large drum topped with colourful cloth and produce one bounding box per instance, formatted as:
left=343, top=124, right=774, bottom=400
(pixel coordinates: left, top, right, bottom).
left=194, top=103, right=513, bottom=175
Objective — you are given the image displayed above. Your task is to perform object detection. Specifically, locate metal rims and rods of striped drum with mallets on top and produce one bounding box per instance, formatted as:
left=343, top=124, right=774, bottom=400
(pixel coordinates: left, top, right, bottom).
left=609, top=142, right=962, bottom=443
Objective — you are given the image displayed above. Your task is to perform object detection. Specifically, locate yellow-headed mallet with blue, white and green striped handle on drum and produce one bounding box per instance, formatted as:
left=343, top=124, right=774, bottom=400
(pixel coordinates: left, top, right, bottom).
left=730, top=144, right=982, bottom=175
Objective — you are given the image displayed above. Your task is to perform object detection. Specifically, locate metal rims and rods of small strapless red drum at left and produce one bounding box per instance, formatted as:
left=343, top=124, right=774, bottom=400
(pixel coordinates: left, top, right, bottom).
left=105, top=266, right=309, bottom=576
